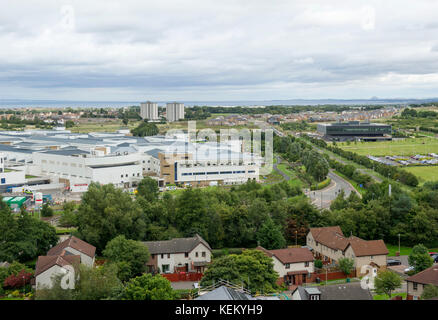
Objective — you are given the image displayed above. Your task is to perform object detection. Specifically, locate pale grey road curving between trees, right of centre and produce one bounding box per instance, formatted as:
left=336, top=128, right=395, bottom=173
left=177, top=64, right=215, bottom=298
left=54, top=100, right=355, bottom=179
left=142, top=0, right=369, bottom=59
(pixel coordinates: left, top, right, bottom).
left=305, top=172, right=357, bottom=209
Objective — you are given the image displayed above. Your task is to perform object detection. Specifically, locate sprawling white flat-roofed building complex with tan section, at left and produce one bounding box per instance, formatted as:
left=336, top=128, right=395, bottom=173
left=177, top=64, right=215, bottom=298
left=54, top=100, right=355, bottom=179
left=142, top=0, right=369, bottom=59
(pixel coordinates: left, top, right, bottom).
left=0, top=130, right=261, bottom=190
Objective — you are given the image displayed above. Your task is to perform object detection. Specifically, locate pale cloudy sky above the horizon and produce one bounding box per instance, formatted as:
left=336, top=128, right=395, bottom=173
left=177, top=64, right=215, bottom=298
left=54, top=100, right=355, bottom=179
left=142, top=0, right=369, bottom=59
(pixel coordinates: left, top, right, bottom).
left=0, top=0, right=438, bottom=101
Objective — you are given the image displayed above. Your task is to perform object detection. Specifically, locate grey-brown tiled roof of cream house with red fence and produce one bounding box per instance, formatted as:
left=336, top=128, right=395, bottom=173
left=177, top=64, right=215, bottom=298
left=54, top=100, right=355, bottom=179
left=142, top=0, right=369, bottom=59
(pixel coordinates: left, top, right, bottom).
left=143, top=234, right=211, bottom=254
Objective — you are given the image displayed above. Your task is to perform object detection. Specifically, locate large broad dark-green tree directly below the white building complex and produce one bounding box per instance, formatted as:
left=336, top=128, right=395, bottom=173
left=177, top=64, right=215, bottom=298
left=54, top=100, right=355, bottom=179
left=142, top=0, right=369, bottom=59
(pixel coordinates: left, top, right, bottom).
left=77, top=183, right=147, bottom=252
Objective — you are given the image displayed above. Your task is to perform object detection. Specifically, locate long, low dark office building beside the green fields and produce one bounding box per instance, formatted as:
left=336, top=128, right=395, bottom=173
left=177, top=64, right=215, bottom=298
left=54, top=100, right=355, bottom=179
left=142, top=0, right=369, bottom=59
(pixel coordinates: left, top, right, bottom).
left=317, top=121, right=391, bottom=141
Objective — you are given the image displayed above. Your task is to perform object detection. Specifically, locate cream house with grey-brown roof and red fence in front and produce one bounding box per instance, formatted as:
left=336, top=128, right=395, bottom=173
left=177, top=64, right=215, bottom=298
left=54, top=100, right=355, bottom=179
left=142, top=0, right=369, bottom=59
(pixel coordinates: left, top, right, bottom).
left=143, top=234, right=212, bottom=273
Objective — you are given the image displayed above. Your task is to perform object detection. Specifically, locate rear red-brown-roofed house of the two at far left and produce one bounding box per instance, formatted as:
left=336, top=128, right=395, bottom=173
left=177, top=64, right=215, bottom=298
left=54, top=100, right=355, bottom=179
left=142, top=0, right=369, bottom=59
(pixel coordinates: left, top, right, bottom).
left=47, top=236, right=96, bottom=267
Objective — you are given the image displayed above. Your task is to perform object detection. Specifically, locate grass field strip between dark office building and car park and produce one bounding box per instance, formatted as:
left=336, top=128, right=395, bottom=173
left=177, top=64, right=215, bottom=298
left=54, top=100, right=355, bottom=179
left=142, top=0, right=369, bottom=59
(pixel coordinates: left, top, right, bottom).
left=337, top=138, right=438, bottom=156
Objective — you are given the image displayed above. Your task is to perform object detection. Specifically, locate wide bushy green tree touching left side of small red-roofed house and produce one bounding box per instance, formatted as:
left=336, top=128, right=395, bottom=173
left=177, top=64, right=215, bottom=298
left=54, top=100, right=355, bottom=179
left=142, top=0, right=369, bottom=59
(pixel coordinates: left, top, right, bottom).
left=201, top=250, right=278, bottom=293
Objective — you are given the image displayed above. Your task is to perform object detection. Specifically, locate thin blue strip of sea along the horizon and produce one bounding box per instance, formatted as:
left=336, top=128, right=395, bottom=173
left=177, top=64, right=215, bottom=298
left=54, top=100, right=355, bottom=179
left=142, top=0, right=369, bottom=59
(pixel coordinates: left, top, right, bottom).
left=0, top=98, right=438, bottom=109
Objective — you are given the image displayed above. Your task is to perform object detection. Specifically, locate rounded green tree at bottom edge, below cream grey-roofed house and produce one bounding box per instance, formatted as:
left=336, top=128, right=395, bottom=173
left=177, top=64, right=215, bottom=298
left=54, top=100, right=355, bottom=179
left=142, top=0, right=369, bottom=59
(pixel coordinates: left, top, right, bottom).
left=124, top=273, right=175, bottom=300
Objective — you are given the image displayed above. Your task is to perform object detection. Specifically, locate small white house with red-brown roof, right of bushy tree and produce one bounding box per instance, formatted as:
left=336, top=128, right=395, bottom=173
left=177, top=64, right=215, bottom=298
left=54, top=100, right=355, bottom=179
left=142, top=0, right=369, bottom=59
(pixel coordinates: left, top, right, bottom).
left=256, top=246, right=315, bottom=285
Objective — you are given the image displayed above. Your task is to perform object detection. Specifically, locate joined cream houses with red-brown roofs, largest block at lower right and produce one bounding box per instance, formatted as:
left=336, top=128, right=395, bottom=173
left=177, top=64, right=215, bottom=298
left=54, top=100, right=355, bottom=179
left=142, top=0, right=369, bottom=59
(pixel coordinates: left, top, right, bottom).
left=306, top=226, right=388, bottom=276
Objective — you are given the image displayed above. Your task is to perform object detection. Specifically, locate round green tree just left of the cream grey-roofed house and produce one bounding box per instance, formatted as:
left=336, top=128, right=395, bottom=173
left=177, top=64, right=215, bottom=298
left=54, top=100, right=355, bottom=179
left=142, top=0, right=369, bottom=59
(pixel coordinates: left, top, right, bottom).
left=103, top=235, right=150, bottom=281
